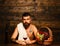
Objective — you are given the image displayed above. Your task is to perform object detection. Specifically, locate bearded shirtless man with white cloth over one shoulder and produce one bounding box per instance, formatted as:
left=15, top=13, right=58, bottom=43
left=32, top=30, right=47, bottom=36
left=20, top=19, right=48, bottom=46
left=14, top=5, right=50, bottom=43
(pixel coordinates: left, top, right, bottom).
left=11, top=13, right=37, bottom=45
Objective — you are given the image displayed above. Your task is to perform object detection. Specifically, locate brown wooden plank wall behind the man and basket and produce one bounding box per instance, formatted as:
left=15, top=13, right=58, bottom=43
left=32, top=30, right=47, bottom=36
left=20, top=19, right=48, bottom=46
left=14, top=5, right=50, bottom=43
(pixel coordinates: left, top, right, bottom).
left=0, top=0, right=60, bottom=43
